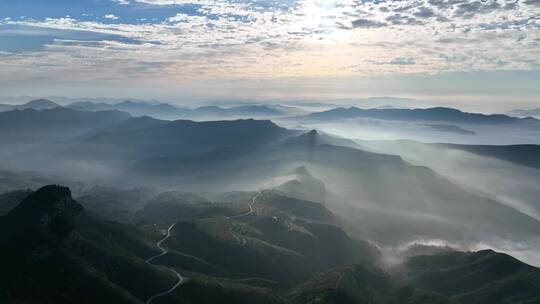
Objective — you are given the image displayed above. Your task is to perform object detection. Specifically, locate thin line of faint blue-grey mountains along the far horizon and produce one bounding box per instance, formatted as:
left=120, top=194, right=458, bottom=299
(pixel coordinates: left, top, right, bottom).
left=7, top=99, right=540, bottom=129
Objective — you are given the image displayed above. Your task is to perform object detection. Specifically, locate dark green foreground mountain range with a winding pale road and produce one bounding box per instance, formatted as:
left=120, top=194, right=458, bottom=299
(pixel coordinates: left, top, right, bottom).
left=0, top=183, right=540, bottom=304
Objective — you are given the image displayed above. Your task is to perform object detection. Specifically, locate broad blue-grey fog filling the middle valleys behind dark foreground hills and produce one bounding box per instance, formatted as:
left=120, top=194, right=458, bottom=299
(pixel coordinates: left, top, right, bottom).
left=0, top=108, right=540, bottom=265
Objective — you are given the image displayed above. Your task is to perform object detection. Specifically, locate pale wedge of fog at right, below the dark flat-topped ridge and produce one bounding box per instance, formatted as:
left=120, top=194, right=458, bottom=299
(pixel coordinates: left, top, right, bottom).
left=361, top=141, right=540, bottom=220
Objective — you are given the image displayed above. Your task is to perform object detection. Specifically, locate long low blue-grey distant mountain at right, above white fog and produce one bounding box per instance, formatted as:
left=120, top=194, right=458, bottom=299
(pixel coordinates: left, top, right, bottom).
left=307, top=107, right=540, bottom=125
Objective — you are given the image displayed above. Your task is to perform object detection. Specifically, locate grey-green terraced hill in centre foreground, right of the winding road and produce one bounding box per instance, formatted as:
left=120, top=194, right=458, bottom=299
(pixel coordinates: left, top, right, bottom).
left=140, top=191, right=380, bottom=286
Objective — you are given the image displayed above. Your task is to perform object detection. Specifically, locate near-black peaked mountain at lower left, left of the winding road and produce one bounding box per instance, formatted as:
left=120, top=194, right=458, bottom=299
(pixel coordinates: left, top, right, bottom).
left=0, top=186, right=181, bottom=303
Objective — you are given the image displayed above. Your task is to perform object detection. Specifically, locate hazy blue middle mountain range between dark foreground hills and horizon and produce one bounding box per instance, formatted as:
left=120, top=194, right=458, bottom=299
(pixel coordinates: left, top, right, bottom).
left=0, top=108, right=540, bottom=249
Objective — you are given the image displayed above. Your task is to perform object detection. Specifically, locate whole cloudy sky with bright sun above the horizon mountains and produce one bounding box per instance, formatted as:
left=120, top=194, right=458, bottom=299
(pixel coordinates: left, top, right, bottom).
left=0, top=0, right=540, bottom=109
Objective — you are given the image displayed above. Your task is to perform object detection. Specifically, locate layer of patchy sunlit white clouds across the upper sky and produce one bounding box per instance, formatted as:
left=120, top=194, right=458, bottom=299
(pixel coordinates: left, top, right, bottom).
left=0, top=0, right=540, bottom=100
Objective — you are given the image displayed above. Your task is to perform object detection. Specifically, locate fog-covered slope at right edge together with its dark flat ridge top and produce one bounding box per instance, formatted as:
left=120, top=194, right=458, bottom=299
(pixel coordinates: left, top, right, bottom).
left=360, top=140, right=540, bottom=224
